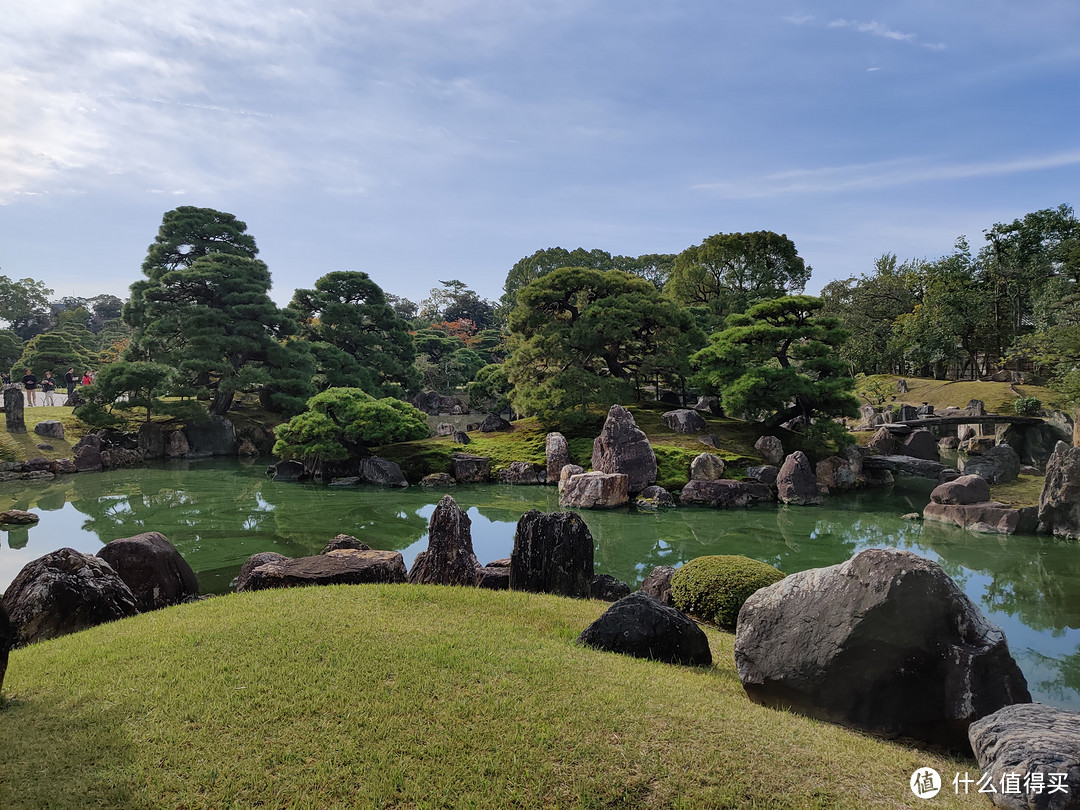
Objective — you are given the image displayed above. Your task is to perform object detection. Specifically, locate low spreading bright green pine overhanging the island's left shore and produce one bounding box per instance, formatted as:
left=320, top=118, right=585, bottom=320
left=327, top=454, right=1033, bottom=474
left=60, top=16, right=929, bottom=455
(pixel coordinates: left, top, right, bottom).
left=273, top=388, right=428, bottom=461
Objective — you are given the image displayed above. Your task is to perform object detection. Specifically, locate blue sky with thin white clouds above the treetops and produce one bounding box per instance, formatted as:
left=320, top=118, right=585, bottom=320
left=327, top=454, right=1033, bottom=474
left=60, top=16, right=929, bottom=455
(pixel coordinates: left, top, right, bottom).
left=0, top=0, right=1080, bottom=303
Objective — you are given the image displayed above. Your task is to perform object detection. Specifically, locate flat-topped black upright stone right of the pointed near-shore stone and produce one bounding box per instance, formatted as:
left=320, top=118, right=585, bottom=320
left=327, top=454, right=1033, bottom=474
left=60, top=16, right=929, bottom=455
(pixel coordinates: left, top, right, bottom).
left=510, top=509, right=594, bottom=598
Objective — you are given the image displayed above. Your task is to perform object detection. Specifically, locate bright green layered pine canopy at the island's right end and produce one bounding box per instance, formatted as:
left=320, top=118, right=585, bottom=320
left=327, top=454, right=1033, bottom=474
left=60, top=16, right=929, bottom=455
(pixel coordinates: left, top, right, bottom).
left=693, top=296, right=859, bottom=427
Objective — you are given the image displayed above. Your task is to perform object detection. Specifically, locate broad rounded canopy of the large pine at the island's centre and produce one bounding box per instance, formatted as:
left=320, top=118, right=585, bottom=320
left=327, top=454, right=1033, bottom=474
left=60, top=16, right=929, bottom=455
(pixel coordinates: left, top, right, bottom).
left=505, top=268, right=703, bottom=427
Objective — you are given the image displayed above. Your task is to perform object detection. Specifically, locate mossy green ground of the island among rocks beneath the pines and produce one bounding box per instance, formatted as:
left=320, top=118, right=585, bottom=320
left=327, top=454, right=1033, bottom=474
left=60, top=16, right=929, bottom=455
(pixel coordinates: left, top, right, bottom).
left=375, top=403, right=773, bottom=489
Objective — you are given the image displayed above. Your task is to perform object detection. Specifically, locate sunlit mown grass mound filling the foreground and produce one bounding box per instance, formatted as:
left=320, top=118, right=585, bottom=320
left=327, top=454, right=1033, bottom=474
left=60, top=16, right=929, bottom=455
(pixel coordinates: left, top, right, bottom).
left=0, top=585, right=985, bottom=810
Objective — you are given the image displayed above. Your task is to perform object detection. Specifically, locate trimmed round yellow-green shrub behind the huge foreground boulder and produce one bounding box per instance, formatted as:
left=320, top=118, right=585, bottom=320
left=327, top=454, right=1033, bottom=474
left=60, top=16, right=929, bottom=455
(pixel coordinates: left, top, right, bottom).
left=672, top=554, right=785, bottom=631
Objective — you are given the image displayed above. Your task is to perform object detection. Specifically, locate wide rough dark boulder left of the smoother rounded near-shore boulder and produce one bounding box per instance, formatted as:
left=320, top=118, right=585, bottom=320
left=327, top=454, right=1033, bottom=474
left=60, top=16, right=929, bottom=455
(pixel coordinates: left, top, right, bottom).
left=3, top=549, right=138, bottom=645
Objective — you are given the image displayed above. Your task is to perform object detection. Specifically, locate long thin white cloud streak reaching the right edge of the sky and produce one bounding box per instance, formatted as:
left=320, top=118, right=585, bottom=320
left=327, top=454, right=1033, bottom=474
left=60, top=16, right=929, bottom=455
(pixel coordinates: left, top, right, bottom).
left=692, top=150, right=1080, bottom=199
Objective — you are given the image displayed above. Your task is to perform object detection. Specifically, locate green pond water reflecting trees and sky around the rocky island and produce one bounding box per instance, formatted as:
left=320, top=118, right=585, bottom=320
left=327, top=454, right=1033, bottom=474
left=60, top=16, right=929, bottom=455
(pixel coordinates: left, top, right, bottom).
left=0, top=460, right=1080, bottom=710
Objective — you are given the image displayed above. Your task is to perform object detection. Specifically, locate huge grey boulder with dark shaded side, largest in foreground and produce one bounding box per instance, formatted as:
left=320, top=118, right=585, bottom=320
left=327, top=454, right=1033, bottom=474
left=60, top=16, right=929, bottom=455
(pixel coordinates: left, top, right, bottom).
left=734, top=549, right=1031, bottom=751
